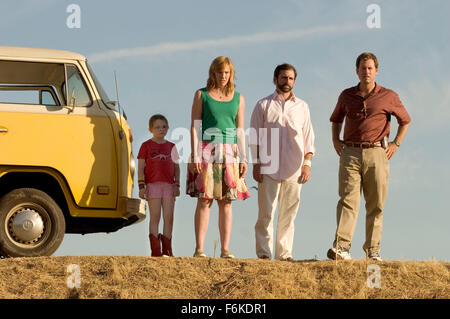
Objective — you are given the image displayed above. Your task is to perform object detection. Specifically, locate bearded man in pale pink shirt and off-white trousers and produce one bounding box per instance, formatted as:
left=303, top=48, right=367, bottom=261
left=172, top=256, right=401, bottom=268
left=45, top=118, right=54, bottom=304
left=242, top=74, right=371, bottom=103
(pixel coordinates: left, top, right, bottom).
left=250, top=63, right=315, bottom=261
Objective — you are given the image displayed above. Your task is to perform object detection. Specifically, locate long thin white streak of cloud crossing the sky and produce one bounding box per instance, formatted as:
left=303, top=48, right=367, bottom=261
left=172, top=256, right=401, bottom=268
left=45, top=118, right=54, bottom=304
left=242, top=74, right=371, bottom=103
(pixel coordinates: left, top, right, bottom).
left=89, top=24, right=362, bottom=63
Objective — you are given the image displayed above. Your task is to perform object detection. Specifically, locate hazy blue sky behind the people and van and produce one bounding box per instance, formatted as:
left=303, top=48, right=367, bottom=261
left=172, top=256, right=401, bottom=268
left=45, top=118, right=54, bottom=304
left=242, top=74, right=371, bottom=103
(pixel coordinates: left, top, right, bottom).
left=0, top=0, right=450, bottom=261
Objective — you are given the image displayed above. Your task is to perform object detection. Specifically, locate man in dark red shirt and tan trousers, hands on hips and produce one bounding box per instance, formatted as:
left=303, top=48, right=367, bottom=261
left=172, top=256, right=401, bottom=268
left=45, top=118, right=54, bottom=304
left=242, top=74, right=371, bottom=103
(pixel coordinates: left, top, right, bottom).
left=327, top=52, right=411, bottom=261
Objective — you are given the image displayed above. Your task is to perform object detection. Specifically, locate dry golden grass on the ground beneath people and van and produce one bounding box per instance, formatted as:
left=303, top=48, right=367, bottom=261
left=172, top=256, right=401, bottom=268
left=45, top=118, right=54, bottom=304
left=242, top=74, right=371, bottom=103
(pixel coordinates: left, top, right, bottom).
left=0, top=256, right=450, bottom=299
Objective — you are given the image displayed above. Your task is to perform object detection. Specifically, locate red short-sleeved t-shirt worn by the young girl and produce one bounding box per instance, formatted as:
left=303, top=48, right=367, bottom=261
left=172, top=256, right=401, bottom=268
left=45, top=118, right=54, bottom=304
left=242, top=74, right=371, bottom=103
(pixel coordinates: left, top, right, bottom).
left=138, top=139, right=179, bottom=184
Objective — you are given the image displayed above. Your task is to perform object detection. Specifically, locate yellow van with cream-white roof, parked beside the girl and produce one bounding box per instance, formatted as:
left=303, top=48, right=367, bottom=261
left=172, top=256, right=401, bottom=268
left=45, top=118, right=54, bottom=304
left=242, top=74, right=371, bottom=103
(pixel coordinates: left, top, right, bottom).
left=0, top=46, right=145, bottom=257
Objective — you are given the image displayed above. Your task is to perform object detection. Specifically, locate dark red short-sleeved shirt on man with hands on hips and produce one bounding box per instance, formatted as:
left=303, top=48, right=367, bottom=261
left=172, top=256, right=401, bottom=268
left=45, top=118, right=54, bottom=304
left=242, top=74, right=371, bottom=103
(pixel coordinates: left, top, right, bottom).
left=330, top=83, right=411, bottom=142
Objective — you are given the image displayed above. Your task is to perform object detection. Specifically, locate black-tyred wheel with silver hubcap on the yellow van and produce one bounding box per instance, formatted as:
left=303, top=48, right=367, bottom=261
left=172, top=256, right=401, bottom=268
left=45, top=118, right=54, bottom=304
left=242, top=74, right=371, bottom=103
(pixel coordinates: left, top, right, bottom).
left=0, top=188, right=66, bottom=257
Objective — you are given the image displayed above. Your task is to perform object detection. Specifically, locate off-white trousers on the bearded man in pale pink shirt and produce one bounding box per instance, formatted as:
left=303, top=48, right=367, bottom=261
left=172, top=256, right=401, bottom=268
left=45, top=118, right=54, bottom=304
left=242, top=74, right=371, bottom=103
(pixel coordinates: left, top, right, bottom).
left=255, top=175, right=302, bottom=259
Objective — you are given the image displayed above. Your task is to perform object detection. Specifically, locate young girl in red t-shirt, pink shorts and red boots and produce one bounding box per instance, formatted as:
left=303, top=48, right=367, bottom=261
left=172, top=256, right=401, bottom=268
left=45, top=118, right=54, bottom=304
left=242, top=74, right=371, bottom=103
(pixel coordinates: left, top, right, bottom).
left=138, top=114, right=180, bottom=257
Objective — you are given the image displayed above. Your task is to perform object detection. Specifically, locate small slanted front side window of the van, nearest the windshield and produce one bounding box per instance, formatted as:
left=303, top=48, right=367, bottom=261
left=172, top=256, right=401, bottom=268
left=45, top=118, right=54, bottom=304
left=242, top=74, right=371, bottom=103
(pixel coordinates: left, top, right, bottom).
left=63, top=64, right=92, bottom=106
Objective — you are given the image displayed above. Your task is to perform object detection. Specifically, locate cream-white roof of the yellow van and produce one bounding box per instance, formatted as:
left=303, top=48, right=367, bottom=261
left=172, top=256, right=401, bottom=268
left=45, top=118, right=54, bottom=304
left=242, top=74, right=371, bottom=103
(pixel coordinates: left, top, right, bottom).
left=0, top=46, right=86, bottom=60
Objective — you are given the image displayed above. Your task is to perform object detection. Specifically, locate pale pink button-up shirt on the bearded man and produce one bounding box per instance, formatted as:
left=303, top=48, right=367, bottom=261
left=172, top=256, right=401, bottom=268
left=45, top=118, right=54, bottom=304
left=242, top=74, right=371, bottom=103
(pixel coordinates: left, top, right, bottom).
left=249, top=91, right=315, bottom=180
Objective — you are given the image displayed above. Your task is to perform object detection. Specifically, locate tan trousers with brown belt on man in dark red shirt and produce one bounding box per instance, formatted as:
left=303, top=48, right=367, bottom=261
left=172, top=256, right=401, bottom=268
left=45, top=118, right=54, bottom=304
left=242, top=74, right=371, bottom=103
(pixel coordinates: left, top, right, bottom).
left=334, top=146, right=389, bottom=252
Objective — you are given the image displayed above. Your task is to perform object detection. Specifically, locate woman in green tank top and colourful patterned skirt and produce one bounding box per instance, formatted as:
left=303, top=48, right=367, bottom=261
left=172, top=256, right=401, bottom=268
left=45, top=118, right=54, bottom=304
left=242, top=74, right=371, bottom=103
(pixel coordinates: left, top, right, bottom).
left=186, top=56, right=249, bottom=258
